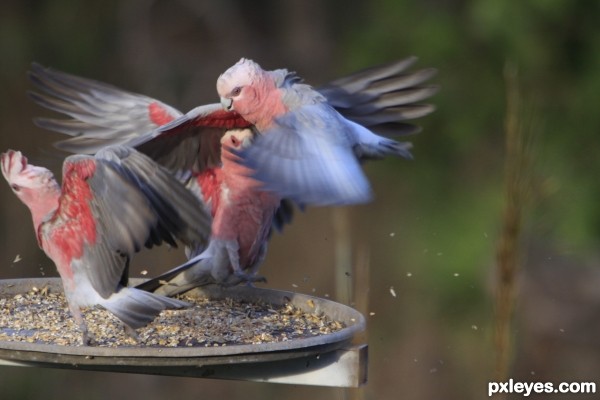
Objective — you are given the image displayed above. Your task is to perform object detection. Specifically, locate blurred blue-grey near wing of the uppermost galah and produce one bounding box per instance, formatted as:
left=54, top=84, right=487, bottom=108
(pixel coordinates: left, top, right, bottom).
left=235, top=103, right=371, bottom=205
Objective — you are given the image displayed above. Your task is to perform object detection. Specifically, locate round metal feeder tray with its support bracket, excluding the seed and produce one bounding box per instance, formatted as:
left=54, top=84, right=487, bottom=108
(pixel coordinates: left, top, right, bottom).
left=0, top=278, right=368, bottom=387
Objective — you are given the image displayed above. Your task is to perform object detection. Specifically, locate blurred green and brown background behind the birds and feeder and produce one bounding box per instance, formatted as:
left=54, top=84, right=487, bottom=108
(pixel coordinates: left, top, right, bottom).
left=0, top=0, right=600, bottom=400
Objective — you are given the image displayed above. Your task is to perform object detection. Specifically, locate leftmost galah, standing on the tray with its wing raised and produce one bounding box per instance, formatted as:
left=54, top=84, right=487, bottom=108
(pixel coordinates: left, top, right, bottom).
left=0, top=146, right=211, bottom=344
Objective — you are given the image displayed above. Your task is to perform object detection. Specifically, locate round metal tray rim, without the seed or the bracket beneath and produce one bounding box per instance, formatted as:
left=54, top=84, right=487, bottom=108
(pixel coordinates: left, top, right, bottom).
left=0, top=278, right=365, bottom=375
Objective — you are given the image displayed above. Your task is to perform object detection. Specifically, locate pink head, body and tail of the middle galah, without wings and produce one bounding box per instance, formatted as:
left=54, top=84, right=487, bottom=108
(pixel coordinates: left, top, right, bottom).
left=138, top=129, right=281, bottom=296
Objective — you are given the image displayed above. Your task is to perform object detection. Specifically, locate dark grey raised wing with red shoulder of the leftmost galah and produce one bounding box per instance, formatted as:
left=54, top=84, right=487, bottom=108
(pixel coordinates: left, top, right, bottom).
left=58, top=147, right=211, bottom=298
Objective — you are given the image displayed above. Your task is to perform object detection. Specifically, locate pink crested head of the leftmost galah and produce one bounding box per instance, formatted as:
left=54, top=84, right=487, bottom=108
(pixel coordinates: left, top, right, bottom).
left=0, top=150, right=58, bottom=205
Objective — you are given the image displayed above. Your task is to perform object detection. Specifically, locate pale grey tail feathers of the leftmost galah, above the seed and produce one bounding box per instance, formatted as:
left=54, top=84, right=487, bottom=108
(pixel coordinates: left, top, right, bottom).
left=101, top=287, right=190, bottom=329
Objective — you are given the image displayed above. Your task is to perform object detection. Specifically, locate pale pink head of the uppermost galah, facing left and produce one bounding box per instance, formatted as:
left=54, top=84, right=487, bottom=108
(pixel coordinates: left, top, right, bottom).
left=217, top=58, right=265, bottom=117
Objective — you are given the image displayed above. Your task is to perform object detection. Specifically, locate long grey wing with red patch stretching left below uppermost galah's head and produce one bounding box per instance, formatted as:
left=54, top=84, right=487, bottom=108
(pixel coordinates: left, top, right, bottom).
left=29, top=64, right=250, bottom=171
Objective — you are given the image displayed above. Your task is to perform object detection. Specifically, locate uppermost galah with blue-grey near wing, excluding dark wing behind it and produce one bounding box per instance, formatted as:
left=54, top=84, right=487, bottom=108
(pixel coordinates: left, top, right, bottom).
left=217, top=58, right=432, bottom=205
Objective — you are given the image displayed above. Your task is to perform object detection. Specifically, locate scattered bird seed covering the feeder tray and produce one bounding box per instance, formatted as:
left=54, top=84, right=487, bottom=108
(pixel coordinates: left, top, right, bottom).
left=0, top=289, right=344, bottom=347
